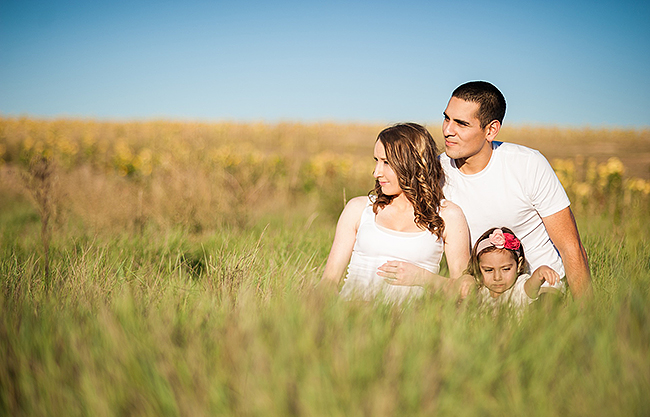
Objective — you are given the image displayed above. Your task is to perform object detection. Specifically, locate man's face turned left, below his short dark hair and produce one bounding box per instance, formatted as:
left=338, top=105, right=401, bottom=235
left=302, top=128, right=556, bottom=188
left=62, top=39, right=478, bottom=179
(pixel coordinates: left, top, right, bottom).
left=442, top=97, right=489, bottom=159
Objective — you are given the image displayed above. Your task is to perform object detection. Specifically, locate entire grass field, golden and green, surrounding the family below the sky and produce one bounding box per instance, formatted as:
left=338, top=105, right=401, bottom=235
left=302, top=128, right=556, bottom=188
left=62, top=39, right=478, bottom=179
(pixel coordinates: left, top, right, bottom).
left=0, top=118, right=650, bottom=416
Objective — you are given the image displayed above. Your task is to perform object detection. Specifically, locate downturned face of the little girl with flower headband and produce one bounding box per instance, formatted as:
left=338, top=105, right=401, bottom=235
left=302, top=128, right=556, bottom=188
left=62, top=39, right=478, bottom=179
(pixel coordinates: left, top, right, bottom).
left=478, top=249, right=517, bottom=298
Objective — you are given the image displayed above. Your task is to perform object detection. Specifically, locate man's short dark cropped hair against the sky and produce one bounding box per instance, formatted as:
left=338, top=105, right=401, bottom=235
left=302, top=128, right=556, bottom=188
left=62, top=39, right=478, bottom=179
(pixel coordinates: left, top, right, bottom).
left=451, top=81, right=506, bottom=129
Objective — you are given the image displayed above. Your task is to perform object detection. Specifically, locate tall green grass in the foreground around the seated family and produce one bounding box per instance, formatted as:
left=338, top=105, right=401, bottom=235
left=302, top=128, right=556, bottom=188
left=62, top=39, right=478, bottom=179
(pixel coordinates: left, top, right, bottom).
left=0, top=193, right=650, bottom=416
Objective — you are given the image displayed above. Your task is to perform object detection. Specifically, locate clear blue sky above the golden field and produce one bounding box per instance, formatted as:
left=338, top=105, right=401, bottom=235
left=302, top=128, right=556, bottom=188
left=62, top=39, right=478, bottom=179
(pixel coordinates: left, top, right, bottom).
left=0, top=0, right=650, bottom=128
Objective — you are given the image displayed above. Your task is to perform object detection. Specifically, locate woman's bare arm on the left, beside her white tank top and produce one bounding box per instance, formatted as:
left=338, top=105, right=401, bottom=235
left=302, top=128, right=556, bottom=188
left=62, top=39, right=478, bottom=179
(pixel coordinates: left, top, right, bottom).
left=321, top=197, right=368, bottom=287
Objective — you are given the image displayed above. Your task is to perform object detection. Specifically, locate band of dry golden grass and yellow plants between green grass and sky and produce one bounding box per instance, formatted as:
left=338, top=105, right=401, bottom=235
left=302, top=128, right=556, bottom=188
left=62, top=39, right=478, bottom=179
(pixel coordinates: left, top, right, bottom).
left=0, top=118, right=650, bottom=232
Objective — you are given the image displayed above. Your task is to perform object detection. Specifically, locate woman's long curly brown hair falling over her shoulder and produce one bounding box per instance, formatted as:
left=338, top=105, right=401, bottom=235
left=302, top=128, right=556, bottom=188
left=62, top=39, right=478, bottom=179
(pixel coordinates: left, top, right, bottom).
left=368, top=123, right=445, bottom=238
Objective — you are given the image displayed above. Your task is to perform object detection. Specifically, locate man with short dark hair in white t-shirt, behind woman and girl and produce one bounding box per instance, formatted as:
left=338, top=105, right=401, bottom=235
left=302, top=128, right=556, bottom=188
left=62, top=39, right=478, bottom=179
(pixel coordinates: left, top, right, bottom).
left=379, top=81, right=591, bottom=298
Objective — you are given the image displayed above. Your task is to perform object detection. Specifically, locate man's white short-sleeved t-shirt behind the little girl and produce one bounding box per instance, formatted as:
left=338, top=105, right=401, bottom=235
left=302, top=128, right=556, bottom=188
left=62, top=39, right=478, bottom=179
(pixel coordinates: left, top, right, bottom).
left=440, top=141, right=570, bottom=287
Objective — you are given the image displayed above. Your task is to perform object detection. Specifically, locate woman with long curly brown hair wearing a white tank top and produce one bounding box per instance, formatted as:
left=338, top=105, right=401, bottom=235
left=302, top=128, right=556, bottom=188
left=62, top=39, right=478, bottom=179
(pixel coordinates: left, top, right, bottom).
left=322, top=123, right=469, bottom=303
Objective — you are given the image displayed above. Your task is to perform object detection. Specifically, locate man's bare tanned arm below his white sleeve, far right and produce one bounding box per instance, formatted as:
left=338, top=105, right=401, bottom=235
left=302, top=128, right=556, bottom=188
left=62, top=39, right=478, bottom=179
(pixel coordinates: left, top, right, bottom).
left=542, top=207, right=592, bottom=298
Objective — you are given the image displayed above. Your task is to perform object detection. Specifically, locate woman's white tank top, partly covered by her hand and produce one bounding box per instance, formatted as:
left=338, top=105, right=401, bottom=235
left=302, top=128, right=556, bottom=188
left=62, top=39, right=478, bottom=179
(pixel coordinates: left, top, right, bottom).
left=340, top=199, right=444, bottom=303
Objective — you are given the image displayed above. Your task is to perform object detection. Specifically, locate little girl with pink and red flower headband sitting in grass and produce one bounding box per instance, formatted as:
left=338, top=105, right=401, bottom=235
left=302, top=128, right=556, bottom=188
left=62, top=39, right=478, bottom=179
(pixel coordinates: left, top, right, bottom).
left=468, top=227, right=560, bottom=311
